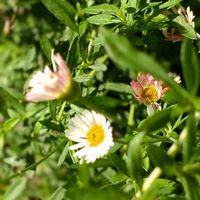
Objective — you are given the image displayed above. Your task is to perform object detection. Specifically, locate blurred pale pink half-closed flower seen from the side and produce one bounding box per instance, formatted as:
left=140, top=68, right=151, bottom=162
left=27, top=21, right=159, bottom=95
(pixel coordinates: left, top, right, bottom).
left=25, top=51, right=72, bottom=102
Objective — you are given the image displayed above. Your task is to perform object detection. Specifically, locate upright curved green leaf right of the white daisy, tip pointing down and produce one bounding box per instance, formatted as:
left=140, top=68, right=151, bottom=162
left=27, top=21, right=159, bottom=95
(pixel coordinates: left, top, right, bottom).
left=128, top=133, right=144, bottom=188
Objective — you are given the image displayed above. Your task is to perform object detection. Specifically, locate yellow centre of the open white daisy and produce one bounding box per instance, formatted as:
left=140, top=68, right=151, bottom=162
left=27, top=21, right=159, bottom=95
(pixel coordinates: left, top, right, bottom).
left=87, top=124, right=105, bottom=147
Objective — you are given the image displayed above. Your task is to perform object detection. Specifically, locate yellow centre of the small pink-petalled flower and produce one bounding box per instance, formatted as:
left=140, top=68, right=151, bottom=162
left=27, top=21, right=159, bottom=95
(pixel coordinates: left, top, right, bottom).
left=142, top=85, right=158, bottom=103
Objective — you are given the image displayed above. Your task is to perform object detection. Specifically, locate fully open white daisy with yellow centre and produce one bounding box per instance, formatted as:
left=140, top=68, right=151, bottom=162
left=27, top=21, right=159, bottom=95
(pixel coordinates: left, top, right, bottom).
left=65, top=110, right=114, bottom=163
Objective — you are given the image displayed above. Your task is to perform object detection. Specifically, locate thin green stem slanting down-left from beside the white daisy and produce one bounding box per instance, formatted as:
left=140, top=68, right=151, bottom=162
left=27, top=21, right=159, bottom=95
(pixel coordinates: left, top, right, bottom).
left=7, top=138, right=67, bottom=181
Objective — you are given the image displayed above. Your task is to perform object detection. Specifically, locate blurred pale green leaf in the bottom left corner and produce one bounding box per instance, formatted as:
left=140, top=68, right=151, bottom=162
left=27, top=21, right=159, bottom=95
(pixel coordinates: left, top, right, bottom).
left=4, top=177, right=27, bottom=200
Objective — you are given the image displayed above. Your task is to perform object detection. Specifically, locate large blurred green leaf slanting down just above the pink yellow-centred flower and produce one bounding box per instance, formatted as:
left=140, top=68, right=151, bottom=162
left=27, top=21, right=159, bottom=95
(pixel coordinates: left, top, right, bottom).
left=100, top=28, right=190, bottom=101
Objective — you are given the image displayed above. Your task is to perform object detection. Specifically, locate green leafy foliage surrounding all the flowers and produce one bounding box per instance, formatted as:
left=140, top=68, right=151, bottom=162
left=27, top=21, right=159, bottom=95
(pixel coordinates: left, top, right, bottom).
left=0, top=0, right=200, bottom=200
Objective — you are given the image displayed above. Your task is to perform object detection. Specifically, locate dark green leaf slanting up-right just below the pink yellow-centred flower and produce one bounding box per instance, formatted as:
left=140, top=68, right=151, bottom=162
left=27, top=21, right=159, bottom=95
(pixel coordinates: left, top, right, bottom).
left=138, top=106, right=176, bottom=132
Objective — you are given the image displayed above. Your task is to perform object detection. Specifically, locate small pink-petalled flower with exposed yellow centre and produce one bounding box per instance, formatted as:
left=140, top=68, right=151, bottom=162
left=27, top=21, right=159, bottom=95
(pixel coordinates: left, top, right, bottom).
left=130, top=74, right=168, bottom=108
